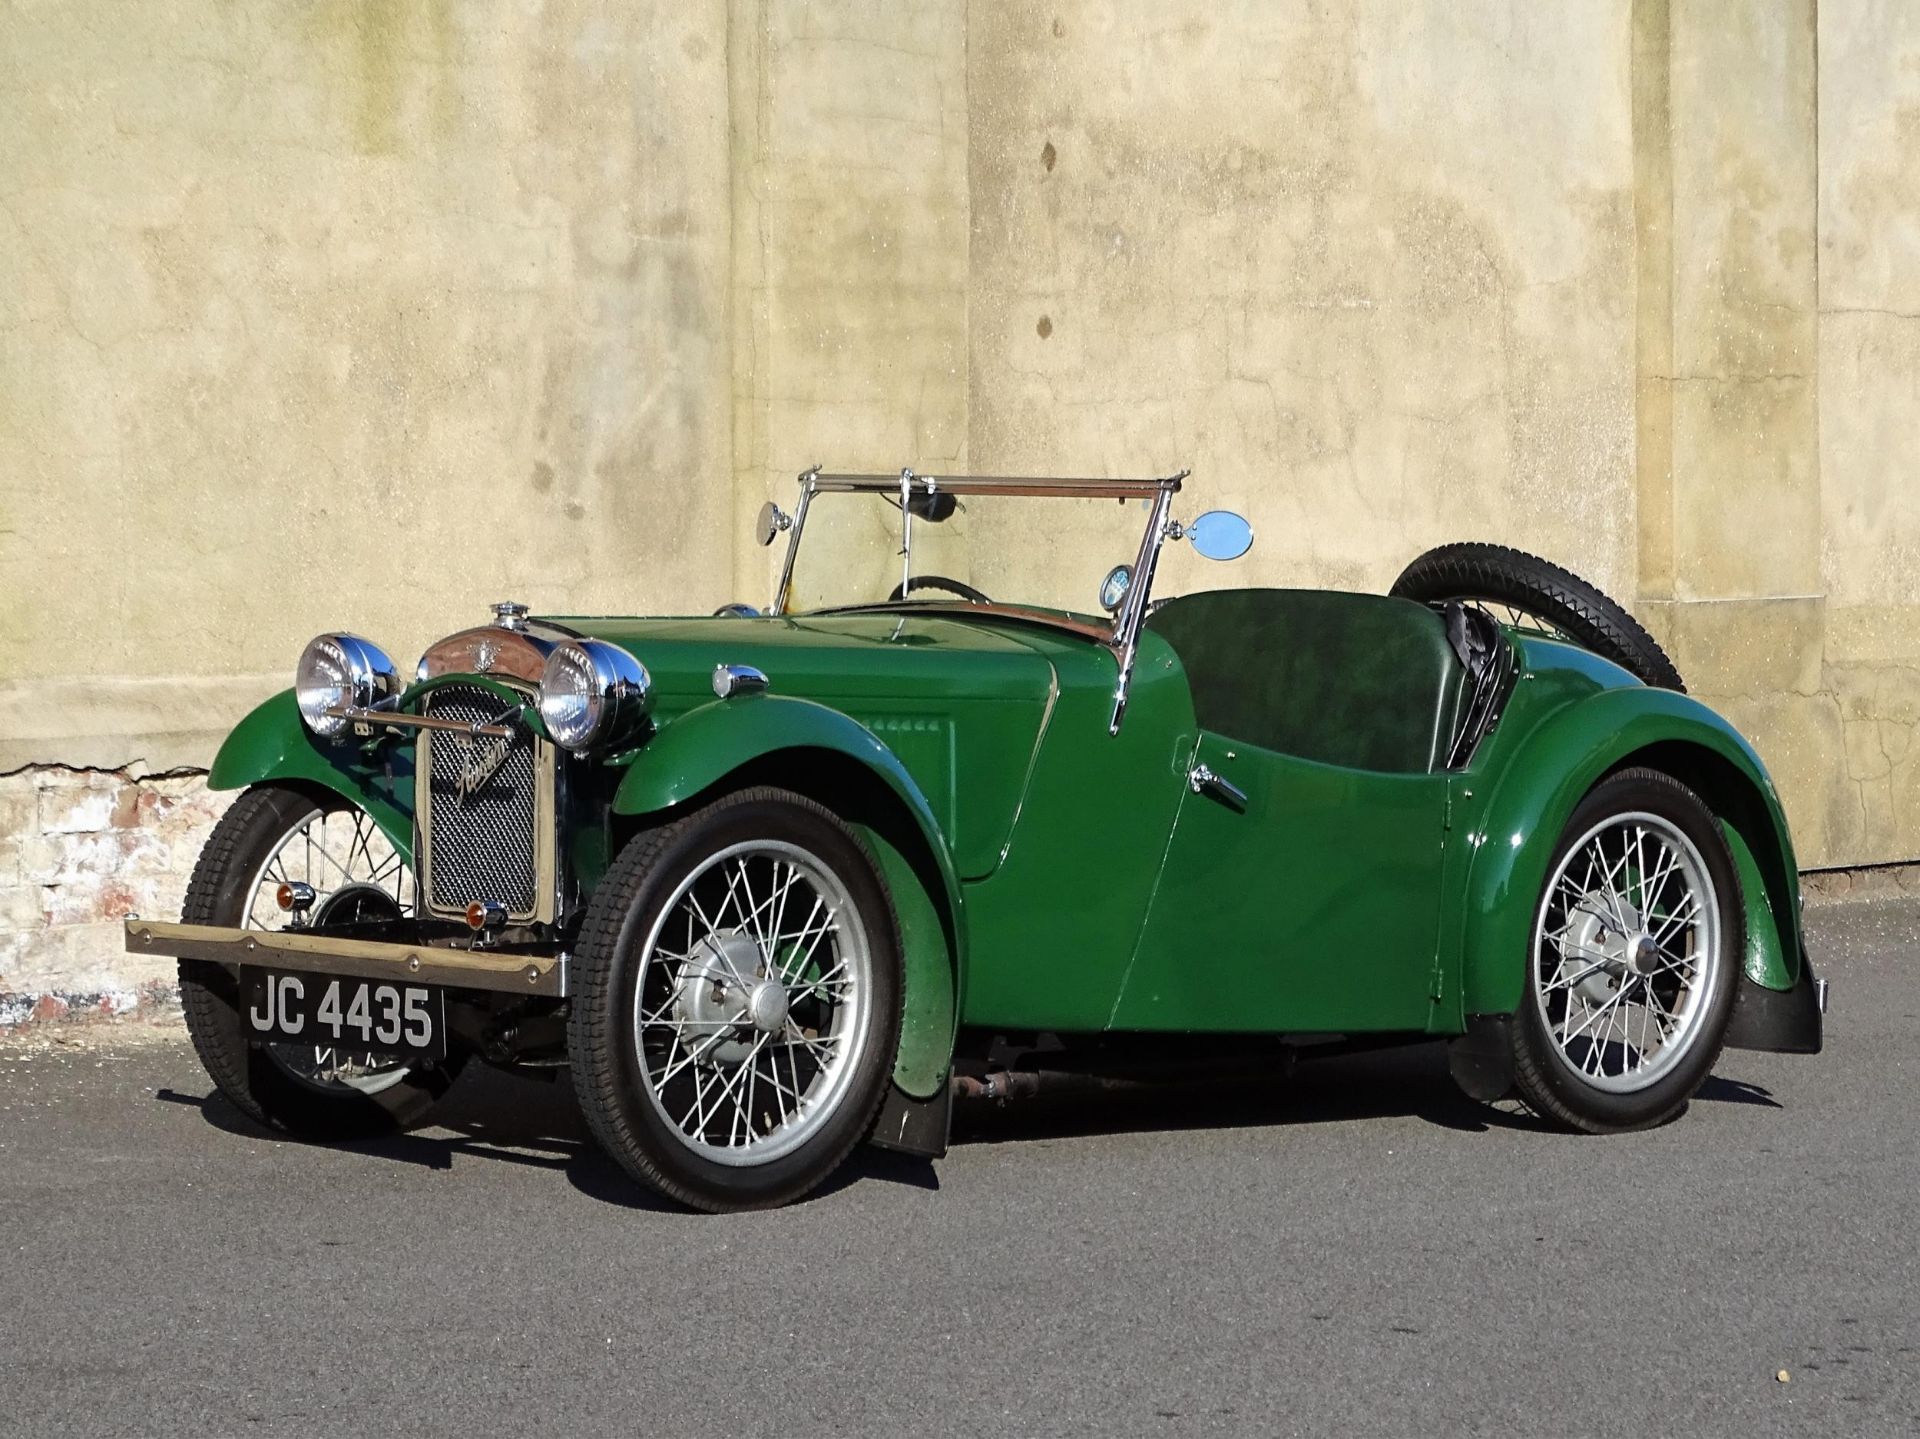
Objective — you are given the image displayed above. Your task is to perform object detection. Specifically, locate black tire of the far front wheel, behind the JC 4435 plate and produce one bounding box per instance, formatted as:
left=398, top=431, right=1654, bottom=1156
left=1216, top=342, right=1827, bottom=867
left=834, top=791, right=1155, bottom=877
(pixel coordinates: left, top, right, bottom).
left=180, top=786, right=463, bottom=1139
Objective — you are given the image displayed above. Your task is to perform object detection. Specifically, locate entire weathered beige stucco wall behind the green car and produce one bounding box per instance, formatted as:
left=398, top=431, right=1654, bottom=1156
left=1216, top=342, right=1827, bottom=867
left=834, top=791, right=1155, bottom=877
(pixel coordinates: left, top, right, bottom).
left=0, top=0, right=1920, bottom=1024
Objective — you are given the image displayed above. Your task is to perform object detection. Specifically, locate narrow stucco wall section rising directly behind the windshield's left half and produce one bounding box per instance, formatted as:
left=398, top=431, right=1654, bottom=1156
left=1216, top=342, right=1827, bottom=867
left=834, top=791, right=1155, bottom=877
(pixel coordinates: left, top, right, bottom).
left=730, top=0, right=968, bottom=605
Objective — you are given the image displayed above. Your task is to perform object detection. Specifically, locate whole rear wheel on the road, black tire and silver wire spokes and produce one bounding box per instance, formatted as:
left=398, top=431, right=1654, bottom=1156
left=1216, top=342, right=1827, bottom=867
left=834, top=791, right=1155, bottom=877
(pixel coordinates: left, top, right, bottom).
left=1509, top=768, right=1745, bottom=1134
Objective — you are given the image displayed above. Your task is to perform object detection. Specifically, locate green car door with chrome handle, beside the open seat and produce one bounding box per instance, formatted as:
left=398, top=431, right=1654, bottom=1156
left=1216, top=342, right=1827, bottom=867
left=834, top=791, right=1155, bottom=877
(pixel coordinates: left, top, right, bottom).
left=1112, top=732, right=1448, bottom=1034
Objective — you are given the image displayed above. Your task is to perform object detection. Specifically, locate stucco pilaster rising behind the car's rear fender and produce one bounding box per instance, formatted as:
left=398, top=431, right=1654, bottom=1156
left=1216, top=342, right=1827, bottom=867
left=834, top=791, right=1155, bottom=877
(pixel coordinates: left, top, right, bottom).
left=1636, top=0, right=1827, bottom=863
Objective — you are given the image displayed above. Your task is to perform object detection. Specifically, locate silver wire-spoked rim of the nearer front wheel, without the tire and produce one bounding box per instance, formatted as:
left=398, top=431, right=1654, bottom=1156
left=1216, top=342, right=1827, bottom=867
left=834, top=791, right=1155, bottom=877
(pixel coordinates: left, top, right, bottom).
left=634, top=840, right=874, bottom=1164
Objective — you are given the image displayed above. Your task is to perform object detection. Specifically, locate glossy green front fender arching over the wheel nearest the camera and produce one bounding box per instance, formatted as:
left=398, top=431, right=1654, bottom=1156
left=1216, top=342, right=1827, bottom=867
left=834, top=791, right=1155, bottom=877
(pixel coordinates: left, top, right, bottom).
left=612, top=694, right=966, bottom=1099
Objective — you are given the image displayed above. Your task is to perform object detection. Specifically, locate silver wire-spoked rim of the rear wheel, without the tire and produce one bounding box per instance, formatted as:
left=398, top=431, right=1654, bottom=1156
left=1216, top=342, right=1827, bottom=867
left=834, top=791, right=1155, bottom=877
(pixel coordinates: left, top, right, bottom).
left=1532, top=811, right=1724, bottom=1095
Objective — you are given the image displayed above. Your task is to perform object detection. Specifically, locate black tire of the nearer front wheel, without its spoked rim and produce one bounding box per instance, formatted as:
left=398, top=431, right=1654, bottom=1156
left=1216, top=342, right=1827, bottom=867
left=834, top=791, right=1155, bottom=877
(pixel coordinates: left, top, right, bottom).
left=566, top=788, right=904, bottom=1212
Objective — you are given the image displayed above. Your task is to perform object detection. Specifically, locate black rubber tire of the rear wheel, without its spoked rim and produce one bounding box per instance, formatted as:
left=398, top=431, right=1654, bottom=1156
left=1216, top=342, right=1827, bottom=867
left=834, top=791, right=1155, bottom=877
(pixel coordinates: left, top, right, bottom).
left=1507, top=768, right=1747, bottom=1134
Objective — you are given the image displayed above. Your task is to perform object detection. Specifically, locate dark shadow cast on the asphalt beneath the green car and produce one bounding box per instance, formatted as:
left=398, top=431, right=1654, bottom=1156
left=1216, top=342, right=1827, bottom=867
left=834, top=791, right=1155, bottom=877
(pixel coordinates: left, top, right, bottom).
left=156, top=1043, right=1782, bottom=1212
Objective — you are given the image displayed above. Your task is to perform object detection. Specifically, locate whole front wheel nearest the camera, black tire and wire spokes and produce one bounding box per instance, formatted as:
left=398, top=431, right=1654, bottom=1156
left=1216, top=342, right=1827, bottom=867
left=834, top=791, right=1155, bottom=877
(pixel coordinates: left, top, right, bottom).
left=568, top=788, right=902, bottom=1210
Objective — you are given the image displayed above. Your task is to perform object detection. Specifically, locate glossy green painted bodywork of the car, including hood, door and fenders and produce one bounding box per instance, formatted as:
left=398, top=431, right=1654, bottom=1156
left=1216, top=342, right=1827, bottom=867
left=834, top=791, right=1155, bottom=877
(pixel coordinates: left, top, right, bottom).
left=194, top=601, right=1801, bottom=1097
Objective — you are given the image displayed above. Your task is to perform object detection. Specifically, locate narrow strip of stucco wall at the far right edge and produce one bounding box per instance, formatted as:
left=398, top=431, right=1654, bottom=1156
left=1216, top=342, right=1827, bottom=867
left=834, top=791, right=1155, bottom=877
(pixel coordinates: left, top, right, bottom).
left=1795, top=0, right=1920, bottom=861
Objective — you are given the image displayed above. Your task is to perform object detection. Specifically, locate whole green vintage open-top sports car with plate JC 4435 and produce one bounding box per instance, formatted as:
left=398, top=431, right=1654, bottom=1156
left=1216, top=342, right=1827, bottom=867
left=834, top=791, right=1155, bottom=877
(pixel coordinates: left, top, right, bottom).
left=127, top=469, right=1824, bottom=1210
